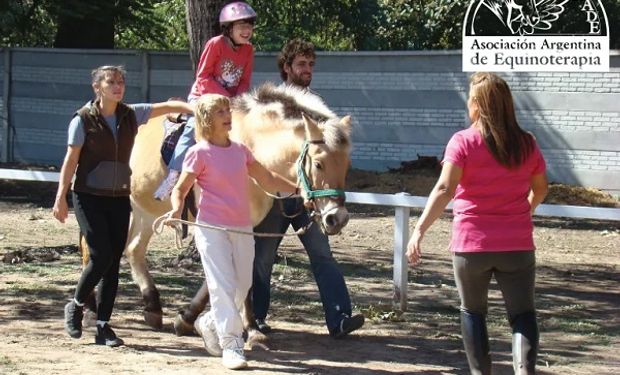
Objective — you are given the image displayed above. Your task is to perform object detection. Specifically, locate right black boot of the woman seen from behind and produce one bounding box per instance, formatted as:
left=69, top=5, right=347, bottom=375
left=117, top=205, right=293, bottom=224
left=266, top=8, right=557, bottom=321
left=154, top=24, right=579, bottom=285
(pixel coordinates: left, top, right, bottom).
left=511, top=312, right=538, bottom=375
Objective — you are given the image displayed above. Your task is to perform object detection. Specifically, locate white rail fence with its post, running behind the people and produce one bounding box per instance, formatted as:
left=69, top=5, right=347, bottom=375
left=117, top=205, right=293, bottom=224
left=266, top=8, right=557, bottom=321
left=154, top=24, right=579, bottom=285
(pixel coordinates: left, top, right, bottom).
left=0, top=168, right=620, bottom=311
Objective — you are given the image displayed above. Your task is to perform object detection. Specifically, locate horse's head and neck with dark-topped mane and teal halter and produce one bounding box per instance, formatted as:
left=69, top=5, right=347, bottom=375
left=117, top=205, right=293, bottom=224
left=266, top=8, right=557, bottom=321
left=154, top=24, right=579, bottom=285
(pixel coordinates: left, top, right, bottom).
left=231, top=83, right=351, bottom=235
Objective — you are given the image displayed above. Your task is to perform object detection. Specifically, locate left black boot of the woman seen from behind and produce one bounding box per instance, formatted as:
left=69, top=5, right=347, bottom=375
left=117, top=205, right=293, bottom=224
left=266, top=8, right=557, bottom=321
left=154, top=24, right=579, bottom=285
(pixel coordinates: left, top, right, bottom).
left=461, top=311, right=491, bottom=375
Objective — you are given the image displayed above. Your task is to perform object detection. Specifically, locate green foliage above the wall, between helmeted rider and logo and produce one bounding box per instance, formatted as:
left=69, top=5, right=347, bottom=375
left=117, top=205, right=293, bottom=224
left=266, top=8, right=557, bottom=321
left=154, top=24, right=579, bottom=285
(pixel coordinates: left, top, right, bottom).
left=252, top=0, right=468, bottom=51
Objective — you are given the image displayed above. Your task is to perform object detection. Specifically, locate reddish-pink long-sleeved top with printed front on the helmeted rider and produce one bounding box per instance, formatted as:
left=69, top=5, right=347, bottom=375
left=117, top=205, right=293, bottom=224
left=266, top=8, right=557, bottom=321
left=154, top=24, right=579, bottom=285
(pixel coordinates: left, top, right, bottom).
left=189, top=35, right=254, bottom=100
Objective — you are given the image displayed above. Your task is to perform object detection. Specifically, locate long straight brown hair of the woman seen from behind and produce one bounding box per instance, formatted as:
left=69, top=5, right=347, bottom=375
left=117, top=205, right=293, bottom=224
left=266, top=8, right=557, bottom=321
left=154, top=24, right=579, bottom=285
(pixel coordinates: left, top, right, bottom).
left=469, top=72, right=534, bottom=168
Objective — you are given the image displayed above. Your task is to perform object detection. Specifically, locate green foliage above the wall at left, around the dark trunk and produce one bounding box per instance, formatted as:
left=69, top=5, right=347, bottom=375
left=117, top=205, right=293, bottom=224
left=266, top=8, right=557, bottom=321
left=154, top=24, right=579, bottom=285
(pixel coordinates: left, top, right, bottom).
left=0, top=0, right=187, bottom=50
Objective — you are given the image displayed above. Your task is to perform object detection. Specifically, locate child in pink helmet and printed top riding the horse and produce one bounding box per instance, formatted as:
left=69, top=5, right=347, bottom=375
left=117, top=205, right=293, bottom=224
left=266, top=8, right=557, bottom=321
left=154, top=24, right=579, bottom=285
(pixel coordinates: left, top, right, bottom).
left=154, top=1, right=256, bottom=200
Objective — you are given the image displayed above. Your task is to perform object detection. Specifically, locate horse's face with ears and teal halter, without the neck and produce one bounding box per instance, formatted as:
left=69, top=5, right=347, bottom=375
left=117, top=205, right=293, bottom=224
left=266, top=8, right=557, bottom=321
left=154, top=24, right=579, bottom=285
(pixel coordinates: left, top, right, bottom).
left=297, top=114, right=351, bottom=235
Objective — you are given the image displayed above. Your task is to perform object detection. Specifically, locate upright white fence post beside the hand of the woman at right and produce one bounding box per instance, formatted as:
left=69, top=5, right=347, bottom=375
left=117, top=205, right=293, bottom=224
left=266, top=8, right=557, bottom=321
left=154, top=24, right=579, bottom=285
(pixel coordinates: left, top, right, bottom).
left=393, top=193, right=411, bottom=311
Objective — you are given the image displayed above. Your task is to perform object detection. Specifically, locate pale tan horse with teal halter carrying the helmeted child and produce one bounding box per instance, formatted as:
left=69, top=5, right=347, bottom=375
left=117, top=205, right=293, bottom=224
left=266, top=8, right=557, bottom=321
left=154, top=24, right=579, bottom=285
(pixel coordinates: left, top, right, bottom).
left=82, top=83, right=351, bottom=335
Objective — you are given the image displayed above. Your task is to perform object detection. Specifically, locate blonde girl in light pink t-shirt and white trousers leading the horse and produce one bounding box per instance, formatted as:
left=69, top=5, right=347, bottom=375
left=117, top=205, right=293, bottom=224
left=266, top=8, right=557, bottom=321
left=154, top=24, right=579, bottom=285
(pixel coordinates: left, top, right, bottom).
left=169, top=94, right=298, bottom=369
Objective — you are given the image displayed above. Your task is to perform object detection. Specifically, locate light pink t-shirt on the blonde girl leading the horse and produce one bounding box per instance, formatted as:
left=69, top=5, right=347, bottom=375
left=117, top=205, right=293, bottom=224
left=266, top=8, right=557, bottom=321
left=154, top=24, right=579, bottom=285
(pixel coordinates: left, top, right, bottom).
left=183, top=141, right=254, bottom=227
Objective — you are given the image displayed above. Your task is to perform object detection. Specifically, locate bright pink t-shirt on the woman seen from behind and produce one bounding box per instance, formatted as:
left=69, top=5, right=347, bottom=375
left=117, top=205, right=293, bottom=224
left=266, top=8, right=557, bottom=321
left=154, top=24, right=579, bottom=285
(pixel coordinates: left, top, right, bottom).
left=443, top=127, right=545, bottom=252
